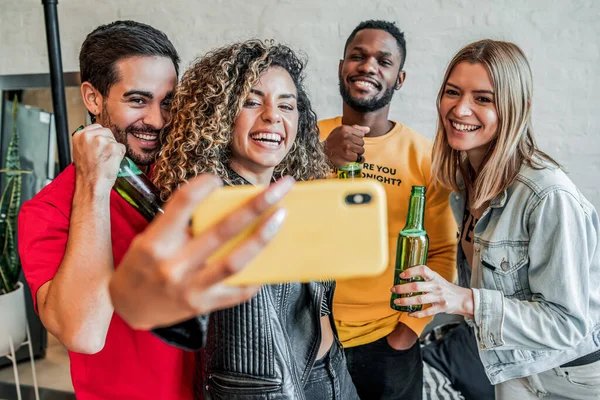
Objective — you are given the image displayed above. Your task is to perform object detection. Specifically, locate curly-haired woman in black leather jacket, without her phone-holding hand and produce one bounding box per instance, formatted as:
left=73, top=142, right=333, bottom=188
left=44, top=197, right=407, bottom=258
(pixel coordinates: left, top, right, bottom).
left=155, top=40, right=358, bottom=399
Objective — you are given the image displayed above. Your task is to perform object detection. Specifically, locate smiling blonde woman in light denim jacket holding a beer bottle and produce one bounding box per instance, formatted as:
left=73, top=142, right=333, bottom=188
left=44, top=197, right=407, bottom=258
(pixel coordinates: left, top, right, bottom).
left=392, top=40, right=600, bottom=400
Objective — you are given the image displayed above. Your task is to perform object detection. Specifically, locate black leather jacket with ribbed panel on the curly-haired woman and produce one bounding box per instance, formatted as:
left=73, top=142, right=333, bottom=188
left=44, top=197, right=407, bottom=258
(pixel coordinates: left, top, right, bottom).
left=154, top=282, right=335, bottom=400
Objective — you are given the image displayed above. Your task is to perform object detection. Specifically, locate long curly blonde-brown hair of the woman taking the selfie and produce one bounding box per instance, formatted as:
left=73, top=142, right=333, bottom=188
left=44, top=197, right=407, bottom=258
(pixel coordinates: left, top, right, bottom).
left=154, top=40, right=329, bottom=199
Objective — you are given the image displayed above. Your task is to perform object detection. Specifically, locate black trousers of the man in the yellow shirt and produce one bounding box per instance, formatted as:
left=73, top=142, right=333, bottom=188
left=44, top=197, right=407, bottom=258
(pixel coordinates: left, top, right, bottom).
left=344, top=337, right=423, bottom=400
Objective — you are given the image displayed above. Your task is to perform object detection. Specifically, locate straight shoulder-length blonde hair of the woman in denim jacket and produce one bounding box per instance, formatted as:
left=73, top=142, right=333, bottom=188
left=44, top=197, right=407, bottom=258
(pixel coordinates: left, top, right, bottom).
left=432, top=39, right=560, bottom=210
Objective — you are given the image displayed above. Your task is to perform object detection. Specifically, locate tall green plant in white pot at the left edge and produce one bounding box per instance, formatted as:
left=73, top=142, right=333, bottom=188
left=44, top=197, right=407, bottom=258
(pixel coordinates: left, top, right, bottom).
left=0, top=96, right=30, bottom=355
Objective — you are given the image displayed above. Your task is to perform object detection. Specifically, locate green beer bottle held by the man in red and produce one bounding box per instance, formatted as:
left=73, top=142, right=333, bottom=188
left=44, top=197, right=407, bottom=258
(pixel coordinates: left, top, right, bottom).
left=113, top=157, right=163, bottom=222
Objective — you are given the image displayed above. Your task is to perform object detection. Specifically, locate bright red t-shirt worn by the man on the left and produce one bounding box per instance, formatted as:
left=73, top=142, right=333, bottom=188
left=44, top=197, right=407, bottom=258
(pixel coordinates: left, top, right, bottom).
left=19, top=165, right=195, bottom=400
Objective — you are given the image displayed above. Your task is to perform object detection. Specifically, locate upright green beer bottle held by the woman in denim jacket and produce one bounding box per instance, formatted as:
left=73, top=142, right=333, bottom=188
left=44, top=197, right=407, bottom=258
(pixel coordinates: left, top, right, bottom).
left=390, top=186, right=429, bottom=312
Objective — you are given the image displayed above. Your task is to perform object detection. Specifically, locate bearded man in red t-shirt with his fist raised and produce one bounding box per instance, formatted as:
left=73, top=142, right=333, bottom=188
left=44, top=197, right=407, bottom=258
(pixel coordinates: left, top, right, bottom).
left=19, top=21, right=194, bottom=400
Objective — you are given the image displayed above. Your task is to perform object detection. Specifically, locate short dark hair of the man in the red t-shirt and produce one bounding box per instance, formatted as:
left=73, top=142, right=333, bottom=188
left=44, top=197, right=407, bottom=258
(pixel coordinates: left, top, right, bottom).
left=79, top=21, right=179, bottom=96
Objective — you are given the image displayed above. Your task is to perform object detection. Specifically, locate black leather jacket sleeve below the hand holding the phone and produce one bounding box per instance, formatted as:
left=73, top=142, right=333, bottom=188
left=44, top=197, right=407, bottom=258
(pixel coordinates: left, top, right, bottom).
left=152, top=314, right=209, bottom=351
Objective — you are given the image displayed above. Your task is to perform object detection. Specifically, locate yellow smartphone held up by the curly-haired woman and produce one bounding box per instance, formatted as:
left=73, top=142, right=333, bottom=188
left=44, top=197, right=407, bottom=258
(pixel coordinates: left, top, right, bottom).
left=192, top=179, right=388, bottom=285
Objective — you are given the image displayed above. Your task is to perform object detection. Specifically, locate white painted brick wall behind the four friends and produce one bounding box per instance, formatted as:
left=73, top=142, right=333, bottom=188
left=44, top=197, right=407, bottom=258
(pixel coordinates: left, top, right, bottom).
left=0, top=0, right=600, bottom=209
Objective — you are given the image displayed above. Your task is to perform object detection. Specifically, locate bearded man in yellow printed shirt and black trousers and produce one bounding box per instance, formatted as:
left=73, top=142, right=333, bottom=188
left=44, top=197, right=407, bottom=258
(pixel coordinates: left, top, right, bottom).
left=319, top=21, right=457, bottom=399
